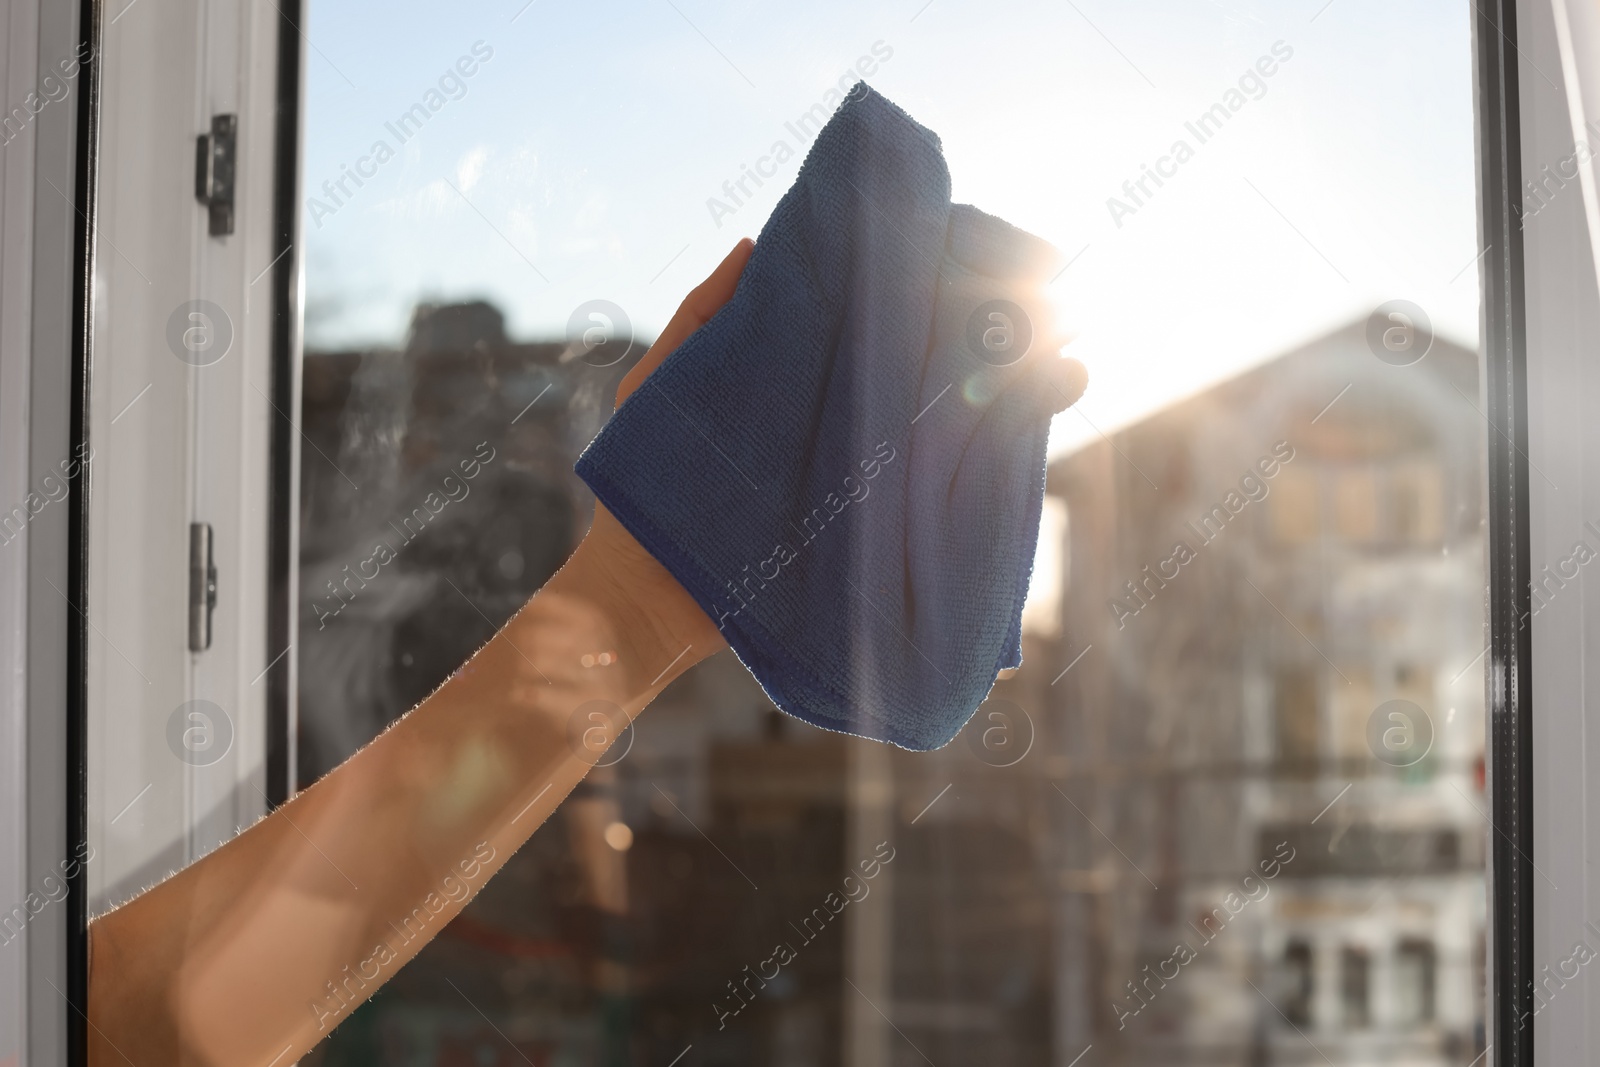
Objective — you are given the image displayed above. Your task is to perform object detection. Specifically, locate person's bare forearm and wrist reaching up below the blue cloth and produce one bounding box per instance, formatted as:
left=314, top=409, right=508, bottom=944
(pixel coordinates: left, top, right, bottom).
left=90, top=534, right=718, bottom=1065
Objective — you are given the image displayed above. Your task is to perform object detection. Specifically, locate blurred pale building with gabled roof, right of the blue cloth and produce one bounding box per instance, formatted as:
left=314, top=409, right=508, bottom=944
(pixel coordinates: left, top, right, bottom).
left=1018, top=323, right=1488, bottom=1064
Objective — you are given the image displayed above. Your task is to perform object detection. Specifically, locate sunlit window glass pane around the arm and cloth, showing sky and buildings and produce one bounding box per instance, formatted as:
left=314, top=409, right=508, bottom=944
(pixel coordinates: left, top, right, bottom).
left=298, top=0, right=1488, bottom=1067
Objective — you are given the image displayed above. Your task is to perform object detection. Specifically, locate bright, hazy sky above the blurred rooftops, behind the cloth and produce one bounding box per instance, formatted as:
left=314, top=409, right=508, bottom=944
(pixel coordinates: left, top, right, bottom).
left=306, top=0, right=1478, bottom=453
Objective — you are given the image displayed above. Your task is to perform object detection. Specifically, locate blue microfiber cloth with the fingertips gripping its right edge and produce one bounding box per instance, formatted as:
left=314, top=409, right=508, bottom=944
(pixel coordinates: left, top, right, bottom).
left=578, top=83, right=1083, bottom=750
